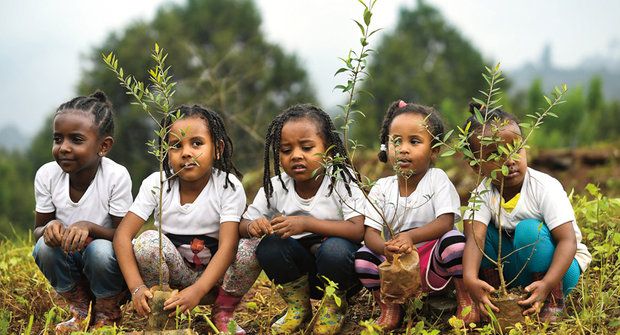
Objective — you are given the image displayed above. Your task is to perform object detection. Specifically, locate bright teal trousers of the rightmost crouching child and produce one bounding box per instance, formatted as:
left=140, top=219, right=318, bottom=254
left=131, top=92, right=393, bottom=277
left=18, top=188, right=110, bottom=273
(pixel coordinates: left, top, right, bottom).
left=480, top=219, right=581, bottom=295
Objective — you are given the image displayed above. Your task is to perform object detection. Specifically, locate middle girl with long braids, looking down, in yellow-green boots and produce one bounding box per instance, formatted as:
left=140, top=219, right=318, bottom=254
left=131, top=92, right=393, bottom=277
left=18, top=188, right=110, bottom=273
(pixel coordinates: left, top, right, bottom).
left=225, top=104, right=364, bottom=334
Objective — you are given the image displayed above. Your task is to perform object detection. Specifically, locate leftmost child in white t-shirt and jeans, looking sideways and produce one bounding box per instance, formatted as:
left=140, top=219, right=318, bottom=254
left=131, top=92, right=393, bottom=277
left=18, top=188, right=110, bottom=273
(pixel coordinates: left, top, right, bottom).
left=33, top=92, right=131, bottom=334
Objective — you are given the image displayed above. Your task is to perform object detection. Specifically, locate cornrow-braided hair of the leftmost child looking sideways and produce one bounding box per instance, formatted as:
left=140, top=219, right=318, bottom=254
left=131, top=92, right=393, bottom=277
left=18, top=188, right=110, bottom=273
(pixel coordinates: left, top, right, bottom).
left=55, top=90, right=114, bottom=138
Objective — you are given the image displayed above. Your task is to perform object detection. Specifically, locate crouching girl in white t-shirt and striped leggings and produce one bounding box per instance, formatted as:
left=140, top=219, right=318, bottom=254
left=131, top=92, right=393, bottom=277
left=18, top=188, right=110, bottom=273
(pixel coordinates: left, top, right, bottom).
left=355, top=101, right=477, bottom=331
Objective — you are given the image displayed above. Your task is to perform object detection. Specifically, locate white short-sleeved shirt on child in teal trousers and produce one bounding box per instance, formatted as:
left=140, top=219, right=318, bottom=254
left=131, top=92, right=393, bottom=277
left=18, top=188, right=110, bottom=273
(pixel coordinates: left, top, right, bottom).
left=463, top=168, right=592, bottom=271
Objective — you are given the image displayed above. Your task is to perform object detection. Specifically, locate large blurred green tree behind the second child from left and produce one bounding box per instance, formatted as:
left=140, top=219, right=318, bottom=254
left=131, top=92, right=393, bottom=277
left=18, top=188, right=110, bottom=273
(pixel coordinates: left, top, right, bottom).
left=27, top=0, right=316, bottom=190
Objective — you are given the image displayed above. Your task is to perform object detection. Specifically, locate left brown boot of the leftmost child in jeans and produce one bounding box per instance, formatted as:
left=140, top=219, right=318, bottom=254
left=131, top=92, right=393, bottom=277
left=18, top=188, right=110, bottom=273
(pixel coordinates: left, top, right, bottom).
left=56, top=282, right=91, bottom=334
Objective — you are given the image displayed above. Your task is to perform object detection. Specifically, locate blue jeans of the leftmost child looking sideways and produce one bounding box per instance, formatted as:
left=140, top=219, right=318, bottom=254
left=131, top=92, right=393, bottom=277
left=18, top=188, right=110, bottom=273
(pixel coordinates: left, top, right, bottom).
left=32, top=237, right=126, bottom=298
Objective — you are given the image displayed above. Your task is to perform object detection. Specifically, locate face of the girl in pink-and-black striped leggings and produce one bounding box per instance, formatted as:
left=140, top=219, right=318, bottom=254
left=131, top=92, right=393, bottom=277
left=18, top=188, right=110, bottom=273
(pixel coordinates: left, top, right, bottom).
left=388, top=113, right=437, bottom=175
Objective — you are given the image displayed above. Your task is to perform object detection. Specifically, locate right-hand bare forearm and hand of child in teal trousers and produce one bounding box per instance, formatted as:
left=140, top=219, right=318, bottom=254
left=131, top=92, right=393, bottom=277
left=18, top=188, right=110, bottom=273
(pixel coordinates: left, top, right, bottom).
left=520, top=221, right=577, bottom=315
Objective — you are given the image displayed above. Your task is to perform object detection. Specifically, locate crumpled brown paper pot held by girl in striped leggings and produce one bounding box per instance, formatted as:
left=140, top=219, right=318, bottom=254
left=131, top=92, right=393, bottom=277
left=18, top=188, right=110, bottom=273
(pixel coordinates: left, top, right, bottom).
left=379, top=250, right=421, bottom=304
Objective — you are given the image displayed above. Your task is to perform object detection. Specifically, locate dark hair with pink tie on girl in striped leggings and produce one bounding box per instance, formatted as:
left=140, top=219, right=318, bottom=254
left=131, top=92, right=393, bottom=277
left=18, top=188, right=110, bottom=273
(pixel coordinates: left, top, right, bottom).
left=377, top=100, right=444, bottom=163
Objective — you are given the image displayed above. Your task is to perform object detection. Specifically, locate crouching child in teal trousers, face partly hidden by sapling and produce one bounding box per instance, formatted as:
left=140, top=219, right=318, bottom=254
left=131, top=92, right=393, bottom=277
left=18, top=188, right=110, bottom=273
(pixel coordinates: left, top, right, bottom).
left=463, top=105, right=592, bottom=321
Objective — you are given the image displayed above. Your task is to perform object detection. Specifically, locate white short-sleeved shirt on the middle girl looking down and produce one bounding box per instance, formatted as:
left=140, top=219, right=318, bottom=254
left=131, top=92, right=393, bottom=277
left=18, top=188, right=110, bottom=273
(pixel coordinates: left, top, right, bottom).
left=243, top=173, right=365, bottom=239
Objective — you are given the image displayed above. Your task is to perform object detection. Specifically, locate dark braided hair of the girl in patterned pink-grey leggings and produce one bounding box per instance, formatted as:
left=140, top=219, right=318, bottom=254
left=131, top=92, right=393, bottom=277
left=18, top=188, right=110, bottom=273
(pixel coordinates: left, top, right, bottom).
left=159, top=105, right=243, bottom=192
